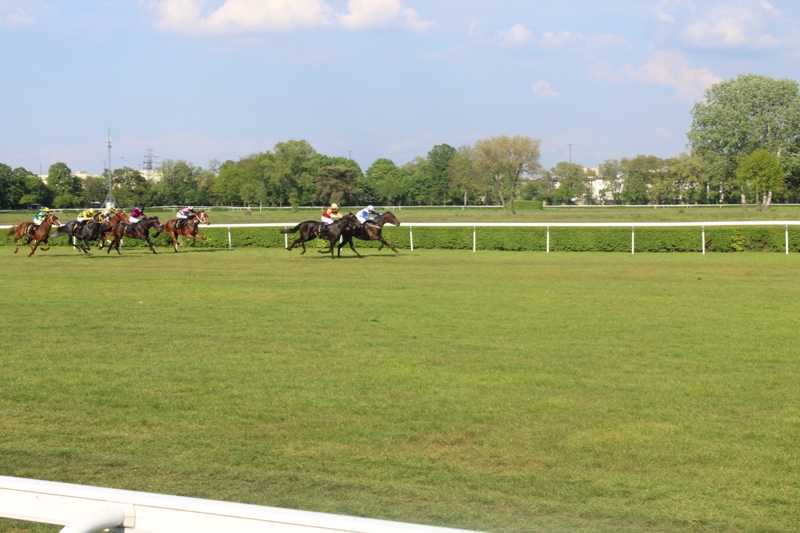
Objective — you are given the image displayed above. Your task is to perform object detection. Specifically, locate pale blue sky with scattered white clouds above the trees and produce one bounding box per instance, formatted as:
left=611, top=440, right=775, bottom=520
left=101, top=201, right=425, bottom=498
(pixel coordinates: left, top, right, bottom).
left=0, top=0, right=800, bottom=173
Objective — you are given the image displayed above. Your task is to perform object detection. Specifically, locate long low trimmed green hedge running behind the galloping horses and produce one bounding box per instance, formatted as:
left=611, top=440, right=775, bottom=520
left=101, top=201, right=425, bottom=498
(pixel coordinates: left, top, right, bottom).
left=0, top=222, right=800, bottom=253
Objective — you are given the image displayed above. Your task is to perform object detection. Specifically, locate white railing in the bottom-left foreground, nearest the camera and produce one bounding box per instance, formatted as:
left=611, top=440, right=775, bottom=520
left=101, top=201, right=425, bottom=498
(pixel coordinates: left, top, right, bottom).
left=0, top=476, right=482, bottom=533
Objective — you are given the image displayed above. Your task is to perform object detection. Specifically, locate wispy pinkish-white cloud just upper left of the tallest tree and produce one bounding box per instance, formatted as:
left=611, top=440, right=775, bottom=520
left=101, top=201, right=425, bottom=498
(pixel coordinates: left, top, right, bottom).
left=591, top=51, right=722, bottom=101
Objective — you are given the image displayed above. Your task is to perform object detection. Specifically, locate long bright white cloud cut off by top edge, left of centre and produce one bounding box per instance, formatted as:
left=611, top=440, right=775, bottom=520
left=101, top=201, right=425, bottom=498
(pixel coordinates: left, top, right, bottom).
left=154, top=0, right=432, bottom=34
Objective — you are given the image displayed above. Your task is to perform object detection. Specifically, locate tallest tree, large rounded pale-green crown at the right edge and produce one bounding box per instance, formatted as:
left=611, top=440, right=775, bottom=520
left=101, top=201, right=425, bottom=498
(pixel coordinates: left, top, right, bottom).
left=687, top=74, right=800, bottom=208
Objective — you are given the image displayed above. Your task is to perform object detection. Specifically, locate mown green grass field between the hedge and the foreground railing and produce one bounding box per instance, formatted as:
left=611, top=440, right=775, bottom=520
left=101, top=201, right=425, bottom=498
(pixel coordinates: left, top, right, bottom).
left=0, top=247, right=800, bottom=533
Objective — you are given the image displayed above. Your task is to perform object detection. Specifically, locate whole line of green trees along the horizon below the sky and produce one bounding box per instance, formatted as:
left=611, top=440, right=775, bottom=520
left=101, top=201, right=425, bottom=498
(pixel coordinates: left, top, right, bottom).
left=0, top=75, right=800, bottom=214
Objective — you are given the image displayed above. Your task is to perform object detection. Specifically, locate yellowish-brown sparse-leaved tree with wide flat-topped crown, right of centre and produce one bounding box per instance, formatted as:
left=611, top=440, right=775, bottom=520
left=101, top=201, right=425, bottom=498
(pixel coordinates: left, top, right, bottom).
left=473, top=135, right=541, bottom=215
